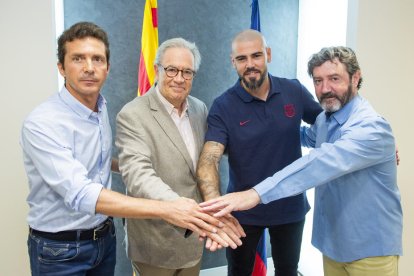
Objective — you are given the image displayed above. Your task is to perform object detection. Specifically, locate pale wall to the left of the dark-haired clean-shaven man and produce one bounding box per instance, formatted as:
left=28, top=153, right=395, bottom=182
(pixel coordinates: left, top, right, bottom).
left=0, top=0, right=57, bottom=275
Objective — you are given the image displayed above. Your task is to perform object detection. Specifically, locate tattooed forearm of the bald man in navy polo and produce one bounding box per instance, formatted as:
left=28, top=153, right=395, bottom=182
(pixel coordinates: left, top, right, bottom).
left=197, top=141, right=224, bottom=200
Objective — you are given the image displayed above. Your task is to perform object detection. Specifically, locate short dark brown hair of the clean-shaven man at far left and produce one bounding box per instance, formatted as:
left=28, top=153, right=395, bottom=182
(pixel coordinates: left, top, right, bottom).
left=57, top=22, right=110, bottom=66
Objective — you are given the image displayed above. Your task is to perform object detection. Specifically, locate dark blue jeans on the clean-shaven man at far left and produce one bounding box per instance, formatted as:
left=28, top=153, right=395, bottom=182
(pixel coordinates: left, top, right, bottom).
left=27, top=226, right=116, bottom=276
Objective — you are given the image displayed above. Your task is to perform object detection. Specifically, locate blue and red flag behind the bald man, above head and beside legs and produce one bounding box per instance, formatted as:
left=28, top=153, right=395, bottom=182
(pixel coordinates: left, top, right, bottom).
left=250, top=0, right=267, bottom=276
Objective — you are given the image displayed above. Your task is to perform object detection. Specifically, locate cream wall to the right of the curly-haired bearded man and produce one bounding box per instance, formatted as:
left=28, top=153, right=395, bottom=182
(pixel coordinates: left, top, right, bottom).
left=348, top=0, right=414, bottom=276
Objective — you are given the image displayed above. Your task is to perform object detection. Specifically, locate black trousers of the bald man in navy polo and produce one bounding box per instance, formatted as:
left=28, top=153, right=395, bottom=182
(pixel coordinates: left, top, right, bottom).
left=226, top=219, right=305, bottom=276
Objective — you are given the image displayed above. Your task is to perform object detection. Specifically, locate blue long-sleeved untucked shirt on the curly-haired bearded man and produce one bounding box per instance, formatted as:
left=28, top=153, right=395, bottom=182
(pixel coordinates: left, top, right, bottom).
left=254, top=96, right=402, bottom=262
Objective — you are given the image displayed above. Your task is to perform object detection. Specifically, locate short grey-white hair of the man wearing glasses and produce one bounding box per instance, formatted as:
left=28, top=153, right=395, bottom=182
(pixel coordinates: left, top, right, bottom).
left=154, top=37, right=201, bottom=72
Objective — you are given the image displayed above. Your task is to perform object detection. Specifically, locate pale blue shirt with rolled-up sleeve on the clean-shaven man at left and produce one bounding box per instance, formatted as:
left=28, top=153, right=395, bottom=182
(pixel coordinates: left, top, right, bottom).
left=20, top=88, right=112, bottom=232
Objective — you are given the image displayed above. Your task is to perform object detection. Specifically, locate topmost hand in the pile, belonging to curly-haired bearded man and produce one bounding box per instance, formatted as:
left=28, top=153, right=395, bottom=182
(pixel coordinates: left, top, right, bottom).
left=200, top=189, right=260, bottom=217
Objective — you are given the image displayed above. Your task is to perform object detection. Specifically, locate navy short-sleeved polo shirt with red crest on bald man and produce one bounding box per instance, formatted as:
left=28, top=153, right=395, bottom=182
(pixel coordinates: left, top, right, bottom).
left=206, top=74, right=322, bottom=226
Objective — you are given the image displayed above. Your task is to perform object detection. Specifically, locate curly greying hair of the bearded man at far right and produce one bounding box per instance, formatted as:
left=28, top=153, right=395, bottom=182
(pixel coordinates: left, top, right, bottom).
left=308, top=46, right=362, bottom=89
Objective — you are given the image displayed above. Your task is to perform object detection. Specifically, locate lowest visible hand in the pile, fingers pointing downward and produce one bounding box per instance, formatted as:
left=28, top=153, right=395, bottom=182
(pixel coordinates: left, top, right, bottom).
left=205, top=215, right=246, bottom=252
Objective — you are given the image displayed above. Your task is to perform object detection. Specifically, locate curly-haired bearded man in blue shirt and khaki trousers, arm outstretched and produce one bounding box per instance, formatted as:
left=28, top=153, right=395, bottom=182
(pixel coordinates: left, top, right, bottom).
left=202, top=47, right=402, bottom=276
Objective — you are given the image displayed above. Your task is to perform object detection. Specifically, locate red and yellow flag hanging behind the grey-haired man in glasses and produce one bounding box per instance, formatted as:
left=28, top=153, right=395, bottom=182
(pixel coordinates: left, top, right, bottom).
left=138, top=0, right=158, bottom=96
